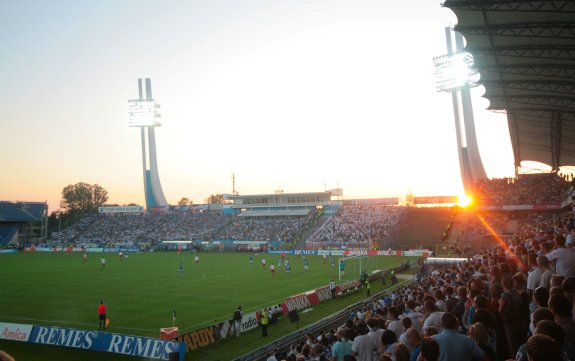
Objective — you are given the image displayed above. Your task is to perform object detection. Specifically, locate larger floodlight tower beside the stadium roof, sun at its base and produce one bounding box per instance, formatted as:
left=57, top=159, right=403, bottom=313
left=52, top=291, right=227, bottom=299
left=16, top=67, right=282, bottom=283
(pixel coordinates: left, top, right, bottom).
left=433, top=27, right=487, bottom=194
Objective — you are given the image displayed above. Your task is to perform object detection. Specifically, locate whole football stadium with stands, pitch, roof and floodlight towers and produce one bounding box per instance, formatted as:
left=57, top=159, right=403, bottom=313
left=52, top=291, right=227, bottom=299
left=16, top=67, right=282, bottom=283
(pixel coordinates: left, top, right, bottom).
left=0, top=0, right=575, bottom=361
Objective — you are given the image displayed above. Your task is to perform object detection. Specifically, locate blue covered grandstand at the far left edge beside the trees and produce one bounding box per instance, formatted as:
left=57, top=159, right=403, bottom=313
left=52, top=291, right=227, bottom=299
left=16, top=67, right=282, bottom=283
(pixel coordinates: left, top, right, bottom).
left=0, top=201, right=48, bottom=248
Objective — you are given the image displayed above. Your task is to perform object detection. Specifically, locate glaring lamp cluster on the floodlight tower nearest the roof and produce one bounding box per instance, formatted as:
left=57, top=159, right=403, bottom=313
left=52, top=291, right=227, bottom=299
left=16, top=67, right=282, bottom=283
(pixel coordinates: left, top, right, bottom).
left=433, top=51, right=479, bottom=92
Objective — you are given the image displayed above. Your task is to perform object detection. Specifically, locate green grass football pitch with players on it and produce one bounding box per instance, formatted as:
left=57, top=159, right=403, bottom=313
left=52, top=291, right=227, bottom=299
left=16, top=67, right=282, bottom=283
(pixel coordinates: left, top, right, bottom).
left=0, top=253, right=410, bottom=359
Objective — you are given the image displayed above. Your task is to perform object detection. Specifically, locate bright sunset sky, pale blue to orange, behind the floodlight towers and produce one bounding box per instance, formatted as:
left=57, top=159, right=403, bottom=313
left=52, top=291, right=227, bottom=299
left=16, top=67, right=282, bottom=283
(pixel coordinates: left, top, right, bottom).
left=0, top=0, right=514, bottom=212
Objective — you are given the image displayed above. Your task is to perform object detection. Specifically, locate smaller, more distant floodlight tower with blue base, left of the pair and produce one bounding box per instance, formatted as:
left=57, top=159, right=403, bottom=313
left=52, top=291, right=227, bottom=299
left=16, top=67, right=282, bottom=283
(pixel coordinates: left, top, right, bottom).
left=128, top=78, right=168, bottom=209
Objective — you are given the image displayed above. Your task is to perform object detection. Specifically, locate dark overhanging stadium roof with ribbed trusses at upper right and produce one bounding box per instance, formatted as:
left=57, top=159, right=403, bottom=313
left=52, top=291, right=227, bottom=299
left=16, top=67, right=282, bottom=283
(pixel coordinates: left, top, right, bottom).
left=443, top=0, right=575, bottom=169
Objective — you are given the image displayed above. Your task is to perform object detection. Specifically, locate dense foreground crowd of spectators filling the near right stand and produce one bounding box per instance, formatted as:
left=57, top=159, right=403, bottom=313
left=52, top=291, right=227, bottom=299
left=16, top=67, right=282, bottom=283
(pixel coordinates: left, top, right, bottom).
left=267, top=204, right=575, bottom=361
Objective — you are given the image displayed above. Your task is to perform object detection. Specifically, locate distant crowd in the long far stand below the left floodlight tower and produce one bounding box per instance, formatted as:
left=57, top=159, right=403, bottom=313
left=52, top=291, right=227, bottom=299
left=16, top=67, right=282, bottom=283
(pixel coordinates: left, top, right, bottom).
left=44, top=210, right=320, bottom=247
